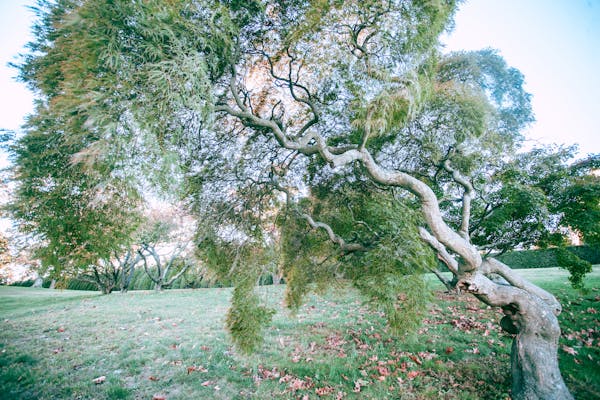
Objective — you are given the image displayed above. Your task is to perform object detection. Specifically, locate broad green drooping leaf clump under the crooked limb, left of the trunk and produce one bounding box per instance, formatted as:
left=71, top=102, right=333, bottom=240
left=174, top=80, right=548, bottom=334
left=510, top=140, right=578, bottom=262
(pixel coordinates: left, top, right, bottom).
left=282, top=185, right=435, bottom=333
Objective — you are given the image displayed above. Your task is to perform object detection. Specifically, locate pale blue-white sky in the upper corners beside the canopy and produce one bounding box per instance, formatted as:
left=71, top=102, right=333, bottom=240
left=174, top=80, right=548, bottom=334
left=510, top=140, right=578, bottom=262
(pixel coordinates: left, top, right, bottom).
left=0, top=0, right=600, bottom=167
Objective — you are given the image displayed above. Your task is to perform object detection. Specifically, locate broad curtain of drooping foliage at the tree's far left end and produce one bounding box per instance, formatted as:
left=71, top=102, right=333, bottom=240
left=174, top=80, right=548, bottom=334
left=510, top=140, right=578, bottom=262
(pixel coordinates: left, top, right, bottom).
left=11, top=0, right=244, bottom=276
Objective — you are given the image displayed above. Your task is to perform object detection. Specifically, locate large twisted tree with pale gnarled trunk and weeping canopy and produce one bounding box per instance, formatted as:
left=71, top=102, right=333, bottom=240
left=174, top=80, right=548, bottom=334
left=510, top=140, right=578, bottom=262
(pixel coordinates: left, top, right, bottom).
left=10, top=0, right=593, bottom=399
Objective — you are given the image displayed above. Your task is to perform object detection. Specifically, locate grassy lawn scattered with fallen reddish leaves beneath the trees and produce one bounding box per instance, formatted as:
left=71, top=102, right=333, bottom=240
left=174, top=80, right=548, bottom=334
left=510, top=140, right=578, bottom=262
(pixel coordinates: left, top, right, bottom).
left=0, top=267, right=600, bottom=400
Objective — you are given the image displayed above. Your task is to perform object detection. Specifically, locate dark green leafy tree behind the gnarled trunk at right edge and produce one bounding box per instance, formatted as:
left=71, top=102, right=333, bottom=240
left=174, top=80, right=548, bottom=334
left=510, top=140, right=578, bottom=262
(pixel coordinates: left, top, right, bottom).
left=471, top=148, right=600, bottom=288
